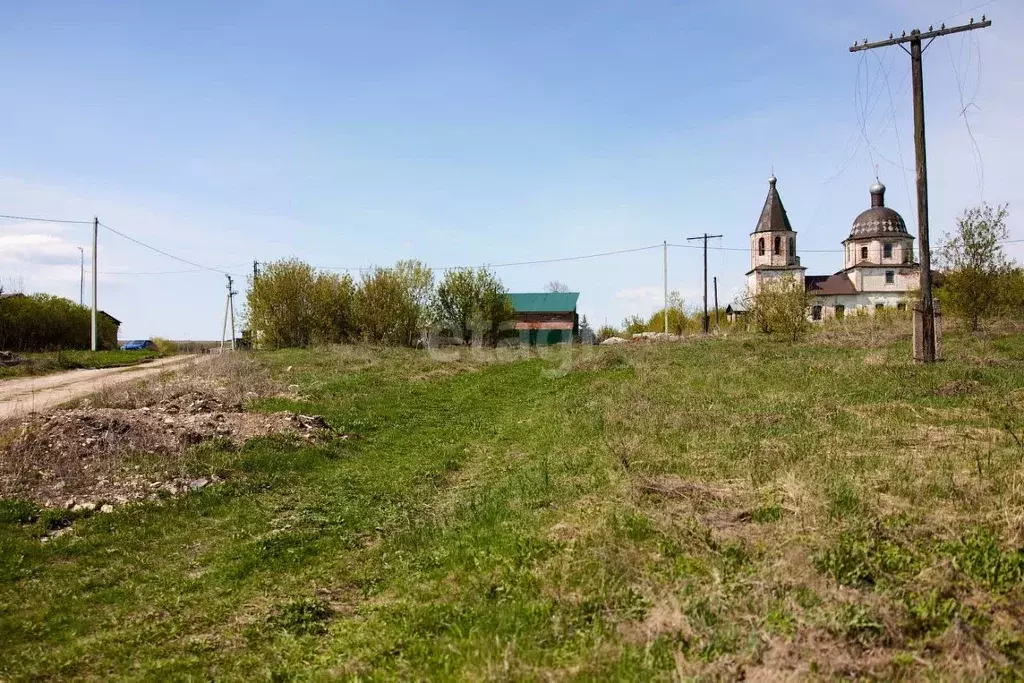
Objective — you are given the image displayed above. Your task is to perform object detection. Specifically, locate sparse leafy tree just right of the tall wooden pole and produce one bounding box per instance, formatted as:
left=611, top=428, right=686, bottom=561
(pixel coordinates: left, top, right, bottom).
left=938, top=204, right=1013, bottom=332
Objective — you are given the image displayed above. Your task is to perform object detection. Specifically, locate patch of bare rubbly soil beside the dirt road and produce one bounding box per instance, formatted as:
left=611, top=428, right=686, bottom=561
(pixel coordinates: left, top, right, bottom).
left=0, top=387, right=331, bottom=511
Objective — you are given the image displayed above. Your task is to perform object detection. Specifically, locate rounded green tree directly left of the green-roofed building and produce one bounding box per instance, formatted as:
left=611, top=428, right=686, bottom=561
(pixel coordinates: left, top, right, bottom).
left=434, top=268, right=515, bottom=345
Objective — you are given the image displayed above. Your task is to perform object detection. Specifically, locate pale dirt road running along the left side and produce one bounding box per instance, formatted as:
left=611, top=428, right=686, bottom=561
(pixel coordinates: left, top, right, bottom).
left=0, top=355, right=200, bottom=420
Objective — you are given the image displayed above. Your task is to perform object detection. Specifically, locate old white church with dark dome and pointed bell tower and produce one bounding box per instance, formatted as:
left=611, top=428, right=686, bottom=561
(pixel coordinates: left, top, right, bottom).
left=746, top=176, right=920, bottom=321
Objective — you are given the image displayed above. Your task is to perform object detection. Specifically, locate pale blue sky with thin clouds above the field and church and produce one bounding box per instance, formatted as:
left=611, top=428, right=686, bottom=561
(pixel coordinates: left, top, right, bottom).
left=0, top=0, right=1024, bottom=339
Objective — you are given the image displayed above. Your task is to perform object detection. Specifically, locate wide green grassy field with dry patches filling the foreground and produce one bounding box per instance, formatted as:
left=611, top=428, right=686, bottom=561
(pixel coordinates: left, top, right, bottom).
left=0, top=329, right=1024, bottom=680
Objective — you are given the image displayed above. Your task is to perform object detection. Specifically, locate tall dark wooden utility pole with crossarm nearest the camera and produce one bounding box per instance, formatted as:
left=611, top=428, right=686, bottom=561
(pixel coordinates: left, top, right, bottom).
left=850, top=15, right=992, bottom=362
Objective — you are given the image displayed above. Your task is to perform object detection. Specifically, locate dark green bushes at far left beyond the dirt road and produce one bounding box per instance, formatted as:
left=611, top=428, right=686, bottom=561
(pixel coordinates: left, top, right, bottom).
left=0, top=294, right=118, bottom=351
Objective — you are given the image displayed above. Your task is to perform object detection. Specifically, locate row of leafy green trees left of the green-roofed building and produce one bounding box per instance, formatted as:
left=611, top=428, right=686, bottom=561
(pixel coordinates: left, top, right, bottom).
left=245, top=259, right=514, bottom=348
